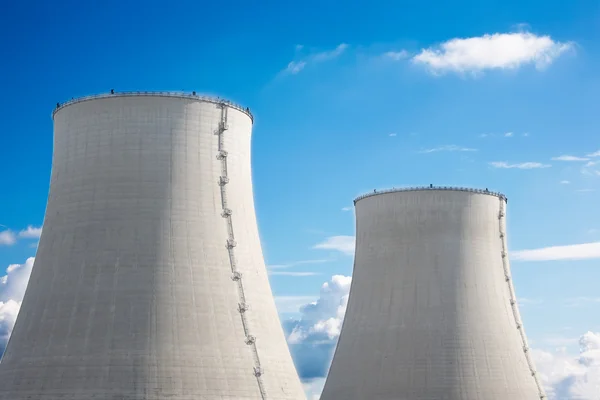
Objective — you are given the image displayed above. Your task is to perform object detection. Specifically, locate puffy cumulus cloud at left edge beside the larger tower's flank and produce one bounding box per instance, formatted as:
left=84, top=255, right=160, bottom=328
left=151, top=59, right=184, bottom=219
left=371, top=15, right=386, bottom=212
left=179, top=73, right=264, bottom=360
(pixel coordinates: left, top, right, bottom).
left=0, top=257, right=34, bottom=354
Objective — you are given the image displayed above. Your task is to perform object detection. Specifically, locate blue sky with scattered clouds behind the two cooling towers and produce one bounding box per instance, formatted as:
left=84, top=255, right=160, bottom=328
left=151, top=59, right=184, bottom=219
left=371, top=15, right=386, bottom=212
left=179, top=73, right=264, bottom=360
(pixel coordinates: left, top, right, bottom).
left=0, top=0, right=600, bottom=396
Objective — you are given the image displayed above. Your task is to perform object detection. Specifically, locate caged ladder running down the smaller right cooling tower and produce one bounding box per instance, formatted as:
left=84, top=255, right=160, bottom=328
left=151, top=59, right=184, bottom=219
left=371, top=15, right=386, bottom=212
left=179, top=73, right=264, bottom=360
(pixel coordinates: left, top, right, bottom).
left=498, top=197, right=546, bottom=399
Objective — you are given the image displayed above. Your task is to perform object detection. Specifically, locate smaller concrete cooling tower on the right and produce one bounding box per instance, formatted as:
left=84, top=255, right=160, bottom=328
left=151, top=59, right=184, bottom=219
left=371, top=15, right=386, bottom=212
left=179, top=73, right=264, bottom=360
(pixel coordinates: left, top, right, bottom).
left=321, top=188, right=544, bottom=400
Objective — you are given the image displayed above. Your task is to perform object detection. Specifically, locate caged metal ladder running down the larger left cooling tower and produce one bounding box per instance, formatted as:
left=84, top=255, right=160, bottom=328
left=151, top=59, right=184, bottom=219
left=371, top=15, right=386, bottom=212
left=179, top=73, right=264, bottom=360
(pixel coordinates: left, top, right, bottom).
left=217, top=103, right=267, bottom=400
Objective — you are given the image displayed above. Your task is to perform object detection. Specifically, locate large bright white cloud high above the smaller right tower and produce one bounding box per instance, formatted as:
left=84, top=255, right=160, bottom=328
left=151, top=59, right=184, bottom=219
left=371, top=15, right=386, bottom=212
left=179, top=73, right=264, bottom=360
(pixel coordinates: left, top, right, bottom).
left=412, top=32, right=574, bottom=74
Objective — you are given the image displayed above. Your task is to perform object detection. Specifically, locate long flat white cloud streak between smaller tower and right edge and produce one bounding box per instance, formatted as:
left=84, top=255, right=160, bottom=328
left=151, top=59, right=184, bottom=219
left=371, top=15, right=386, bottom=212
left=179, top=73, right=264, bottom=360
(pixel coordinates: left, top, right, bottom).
left=511, top=242, right=600, bottom=261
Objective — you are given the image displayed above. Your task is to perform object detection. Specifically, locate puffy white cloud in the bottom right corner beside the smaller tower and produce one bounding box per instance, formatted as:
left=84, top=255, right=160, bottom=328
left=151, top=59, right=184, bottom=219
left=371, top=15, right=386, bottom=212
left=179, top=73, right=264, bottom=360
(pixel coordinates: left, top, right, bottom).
left=532, top=332, right=600, bottom=400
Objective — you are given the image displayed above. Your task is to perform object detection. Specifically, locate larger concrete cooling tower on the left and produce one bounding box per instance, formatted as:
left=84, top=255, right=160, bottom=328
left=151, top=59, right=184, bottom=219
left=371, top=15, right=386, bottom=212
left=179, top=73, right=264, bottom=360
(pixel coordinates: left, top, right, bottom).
left=0, top=93, right=305, bottom=400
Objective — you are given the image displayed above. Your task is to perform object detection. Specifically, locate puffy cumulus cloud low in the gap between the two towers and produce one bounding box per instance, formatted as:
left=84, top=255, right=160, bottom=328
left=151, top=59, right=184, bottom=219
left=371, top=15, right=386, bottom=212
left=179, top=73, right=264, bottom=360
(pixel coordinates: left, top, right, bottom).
left=283, top=275, right=351, bottom=386
